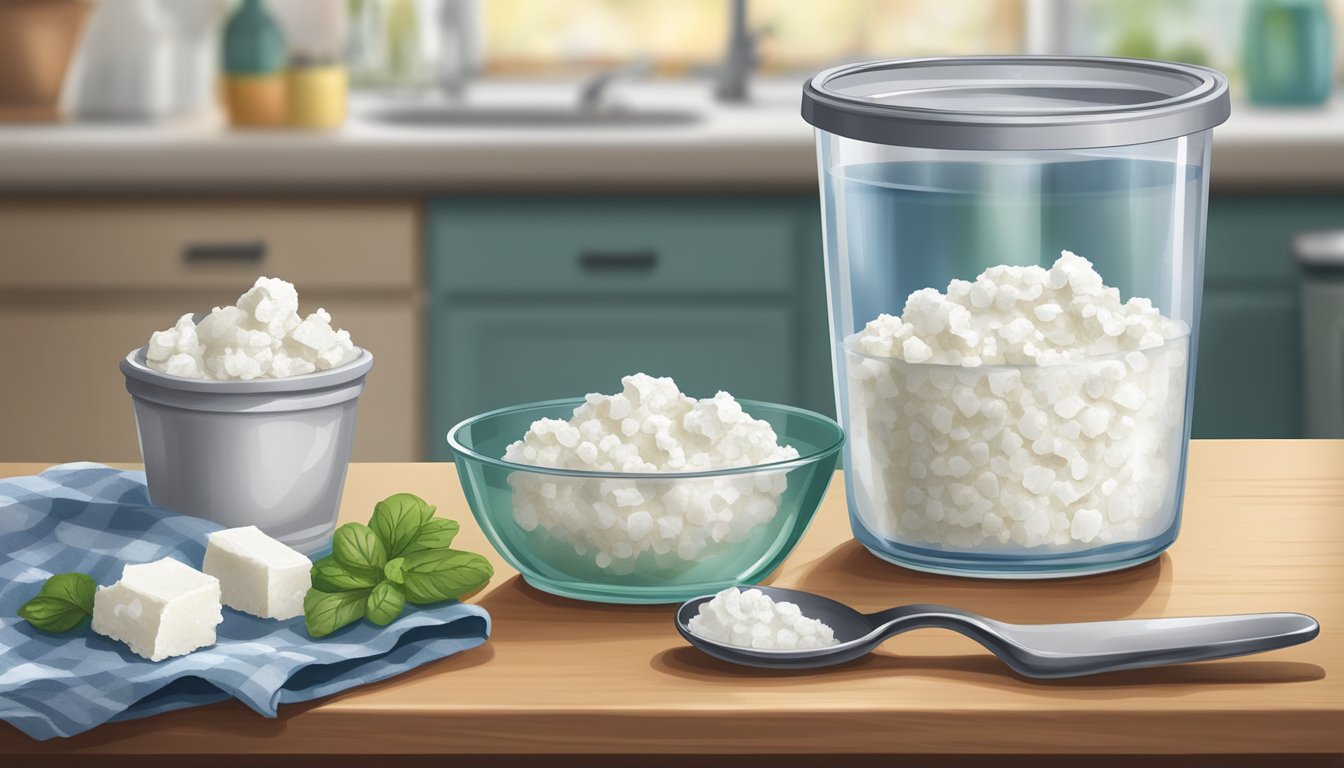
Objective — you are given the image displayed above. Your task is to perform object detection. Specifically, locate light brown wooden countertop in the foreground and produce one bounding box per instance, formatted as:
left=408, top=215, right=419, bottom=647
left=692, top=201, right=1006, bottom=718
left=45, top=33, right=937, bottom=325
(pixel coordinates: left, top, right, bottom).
left=0, top=441, right=1344, bottom=765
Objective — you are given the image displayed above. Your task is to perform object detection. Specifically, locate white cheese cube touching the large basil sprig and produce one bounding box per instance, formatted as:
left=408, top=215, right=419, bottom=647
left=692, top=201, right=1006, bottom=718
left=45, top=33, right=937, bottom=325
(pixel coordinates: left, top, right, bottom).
left=204, top=526, right=313, bottom=619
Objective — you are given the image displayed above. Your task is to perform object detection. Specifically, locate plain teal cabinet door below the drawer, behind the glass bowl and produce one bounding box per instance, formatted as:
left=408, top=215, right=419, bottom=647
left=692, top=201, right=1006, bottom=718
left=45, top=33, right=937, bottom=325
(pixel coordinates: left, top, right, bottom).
left=427, top=303, right=801, bottom=460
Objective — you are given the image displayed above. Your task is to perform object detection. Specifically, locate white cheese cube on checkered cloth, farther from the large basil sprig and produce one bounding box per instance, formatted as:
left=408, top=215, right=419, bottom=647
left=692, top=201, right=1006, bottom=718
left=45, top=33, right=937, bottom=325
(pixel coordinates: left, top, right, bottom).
left=93, top=557, right=223, bottom=662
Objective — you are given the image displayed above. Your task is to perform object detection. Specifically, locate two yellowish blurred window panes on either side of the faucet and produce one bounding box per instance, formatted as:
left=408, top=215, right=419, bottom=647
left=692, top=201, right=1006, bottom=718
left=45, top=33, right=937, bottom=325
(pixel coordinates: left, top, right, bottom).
left=485, top=0, right=1024, bottom=75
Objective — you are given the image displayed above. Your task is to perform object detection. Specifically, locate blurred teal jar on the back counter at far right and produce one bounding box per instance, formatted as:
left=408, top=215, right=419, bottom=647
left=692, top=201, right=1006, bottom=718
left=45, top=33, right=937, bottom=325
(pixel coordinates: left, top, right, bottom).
left=1242, top=0, right=1335, bottom=106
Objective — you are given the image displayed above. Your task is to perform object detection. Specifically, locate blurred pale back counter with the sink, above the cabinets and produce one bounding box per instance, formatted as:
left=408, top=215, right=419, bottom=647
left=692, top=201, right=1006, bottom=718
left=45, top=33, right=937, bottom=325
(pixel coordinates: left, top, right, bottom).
left=0, top=78, right=1344, bottom=194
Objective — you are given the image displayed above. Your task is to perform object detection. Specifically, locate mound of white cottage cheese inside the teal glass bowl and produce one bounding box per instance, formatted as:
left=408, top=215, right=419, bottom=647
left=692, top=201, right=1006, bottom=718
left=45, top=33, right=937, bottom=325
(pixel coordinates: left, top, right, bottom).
left=504, top=374, right=798, bottom=574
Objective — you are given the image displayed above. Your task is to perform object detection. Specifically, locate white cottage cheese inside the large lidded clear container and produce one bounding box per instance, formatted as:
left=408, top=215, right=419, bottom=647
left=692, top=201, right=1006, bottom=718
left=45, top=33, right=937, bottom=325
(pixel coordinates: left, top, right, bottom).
left=844, top=252, right=1189, bottom=551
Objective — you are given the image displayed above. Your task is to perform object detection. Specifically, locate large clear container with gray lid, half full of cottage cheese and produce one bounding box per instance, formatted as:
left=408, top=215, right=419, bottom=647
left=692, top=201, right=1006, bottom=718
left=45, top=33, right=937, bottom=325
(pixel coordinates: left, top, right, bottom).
left=802, top=56, right=1228, bottom=578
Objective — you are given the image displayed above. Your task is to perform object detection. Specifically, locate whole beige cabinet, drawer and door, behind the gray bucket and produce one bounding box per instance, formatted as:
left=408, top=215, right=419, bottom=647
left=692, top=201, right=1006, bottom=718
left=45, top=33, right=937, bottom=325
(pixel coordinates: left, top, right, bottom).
left=0, top=199, right=423, bottom=463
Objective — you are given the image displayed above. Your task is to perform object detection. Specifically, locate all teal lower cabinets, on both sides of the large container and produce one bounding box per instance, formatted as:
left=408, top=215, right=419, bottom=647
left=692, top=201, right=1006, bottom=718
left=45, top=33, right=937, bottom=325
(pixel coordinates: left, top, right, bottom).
left=426, top=195, right=1344, bottom=459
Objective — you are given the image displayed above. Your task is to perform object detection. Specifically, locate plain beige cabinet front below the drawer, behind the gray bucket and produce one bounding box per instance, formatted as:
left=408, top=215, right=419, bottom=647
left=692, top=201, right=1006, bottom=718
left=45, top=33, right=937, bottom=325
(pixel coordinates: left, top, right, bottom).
left=0, top=292, right=425, bottom=463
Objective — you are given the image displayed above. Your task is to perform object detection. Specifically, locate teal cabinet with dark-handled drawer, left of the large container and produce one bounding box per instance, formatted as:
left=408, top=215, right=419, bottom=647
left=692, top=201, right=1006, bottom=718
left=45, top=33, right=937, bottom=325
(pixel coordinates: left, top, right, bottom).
left=426, top=196, right=835, bottom=460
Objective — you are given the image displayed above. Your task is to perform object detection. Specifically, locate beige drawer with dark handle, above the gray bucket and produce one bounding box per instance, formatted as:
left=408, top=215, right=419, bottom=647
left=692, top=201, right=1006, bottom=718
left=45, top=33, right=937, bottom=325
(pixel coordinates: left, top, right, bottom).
left=0, top=199, right=419, bottom=291
